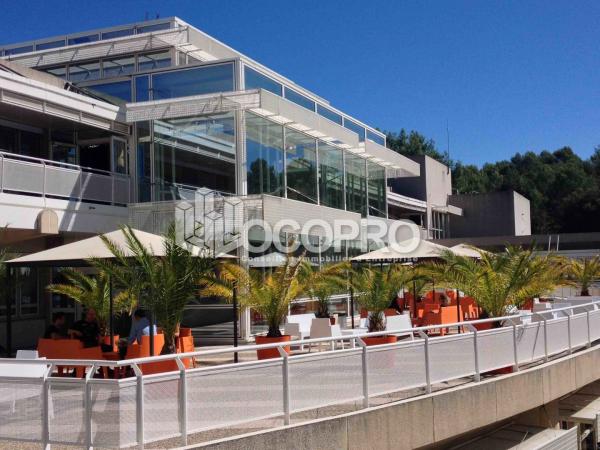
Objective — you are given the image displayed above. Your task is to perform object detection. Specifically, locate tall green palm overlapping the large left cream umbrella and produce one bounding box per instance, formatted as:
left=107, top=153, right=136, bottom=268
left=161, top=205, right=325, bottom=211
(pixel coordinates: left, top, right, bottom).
left=94, top=225, right=216, bottom=353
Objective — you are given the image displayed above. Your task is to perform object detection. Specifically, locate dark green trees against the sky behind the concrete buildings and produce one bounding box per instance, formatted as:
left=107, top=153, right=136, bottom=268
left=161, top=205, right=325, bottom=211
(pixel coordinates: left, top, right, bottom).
left=387, top=130, right=600, bottom=233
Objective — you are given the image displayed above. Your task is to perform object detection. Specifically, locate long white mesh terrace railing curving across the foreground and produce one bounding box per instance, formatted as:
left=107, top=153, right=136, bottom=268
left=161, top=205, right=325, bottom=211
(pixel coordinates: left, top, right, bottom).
left=0, top=302, right=600, bottom=448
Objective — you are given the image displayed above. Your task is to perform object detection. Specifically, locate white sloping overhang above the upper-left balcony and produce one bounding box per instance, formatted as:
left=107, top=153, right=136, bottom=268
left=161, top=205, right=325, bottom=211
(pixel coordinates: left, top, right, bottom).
left=0, top=71, right=129, bottom=134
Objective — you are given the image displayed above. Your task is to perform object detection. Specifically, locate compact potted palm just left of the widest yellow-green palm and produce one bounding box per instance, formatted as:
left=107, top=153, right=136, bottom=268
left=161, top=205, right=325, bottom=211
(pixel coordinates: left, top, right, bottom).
left=353, top=264, right=422, bottom=332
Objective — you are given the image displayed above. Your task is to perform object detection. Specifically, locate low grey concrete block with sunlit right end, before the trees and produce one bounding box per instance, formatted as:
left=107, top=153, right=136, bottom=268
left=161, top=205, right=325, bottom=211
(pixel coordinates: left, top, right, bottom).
left=449, top=191, right=531, bottom=238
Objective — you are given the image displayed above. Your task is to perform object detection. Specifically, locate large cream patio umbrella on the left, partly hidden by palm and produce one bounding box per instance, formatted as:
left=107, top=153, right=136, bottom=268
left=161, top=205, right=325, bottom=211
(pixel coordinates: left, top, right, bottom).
left=6, top=229, right=235, bottom=354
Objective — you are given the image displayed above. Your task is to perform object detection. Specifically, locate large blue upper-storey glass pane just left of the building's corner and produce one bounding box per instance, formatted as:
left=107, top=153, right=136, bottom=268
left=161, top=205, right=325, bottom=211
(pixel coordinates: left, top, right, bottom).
left=152, top=64, right=234, bottom=100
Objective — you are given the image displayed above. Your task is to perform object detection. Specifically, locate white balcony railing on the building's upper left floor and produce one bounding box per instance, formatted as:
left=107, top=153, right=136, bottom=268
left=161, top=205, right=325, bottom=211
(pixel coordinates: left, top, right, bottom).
left=0, top=151, right=130, bottom=205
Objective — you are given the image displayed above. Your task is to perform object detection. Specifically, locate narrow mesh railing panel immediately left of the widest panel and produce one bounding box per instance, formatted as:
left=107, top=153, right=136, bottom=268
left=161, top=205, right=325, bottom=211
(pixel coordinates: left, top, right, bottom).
left=144, top=375, right=179, bottom=442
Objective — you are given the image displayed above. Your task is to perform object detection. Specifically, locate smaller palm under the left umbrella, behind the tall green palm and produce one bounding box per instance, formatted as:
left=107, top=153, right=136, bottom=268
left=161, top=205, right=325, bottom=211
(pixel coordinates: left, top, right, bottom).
left=47, top=269, right=131, bottom=336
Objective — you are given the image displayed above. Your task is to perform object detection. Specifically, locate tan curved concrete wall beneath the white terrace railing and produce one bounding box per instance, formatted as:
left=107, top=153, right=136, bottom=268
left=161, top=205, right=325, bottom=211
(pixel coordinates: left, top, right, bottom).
left=190, top=346, right=600, bottom=450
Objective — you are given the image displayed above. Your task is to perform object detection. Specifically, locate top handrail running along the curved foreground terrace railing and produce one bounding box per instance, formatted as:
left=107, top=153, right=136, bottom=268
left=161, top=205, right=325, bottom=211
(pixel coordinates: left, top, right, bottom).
left=0, top=300, right=600, bottom=370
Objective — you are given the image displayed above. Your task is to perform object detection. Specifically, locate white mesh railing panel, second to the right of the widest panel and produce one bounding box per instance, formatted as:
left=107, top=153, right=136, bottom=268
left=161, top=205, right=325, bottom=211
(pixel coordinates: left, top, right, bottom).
left=367, top=340, right=427, bottom=395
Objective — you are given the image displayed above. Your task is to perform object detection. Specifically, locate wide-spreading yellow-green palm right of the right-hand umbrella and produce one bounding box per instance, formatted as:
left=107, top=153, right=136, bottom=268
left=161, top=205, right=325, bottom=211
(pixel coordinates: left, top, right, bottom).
left=424, top=247, right=564, bottom=317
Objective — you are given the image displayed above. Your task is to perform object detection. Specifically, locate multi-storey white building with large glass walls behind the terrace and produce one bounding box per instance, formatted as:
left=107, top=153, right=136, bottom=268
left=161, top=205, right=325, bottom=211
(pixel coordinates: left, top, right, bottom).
left=0, top=18, right=468, bottom=342
